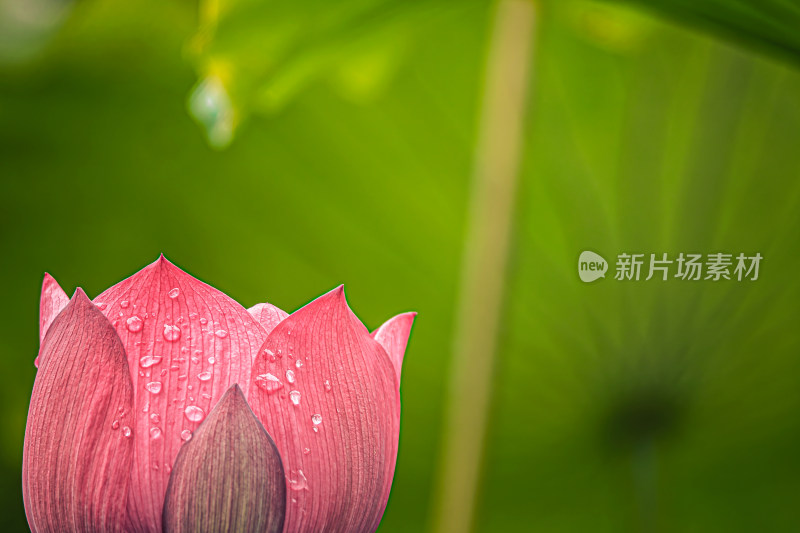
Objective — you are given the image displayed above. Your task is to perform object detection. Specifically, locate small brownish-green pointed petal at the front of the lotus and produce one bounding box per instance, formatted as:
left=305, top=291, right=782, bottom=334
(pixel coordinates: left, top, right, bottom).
left=164, top=385, right=286, bottom=533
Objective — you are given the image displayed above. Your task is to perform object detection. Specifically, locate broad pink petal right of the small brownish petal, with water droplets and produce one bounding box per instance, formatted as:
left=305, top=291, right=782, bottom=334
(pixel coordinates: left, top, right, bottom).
left=248, top=287, right=399, bottom=533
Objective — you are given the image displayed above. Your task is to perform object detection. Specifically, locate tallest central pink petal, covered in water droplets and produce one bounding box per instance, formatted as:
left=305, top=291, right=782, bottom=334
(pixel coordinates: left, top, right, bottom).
left=95, top=256, right=266, bottom=531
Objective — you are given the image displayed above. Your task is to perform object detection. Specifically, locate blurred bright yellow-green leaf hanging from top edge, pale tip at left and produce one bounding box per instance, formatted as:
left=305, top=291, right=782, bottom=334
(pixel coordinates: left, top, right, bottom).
left=184, top=0, right=454, bottom=148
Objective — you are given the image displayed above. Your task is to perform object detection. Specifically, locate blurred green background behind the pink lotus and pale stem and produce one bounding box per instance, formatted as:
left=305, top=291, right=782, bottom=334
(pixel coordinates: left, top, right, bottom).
left=0, top=0, right=800, bottom=533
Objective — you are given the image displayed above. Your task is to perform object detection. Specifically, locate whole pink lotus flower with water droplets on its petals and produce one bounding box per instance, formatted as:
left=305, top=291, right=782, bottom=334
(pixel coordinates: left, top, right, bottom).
left=22, top=256, right=415, bottom=533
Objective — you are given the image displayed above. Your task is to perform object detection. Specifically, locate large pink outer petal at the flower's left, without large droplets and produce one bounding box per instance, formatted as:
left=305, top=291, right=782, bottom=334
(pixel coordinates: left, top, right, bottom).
left=22, top=289, right=134, bottom=532
